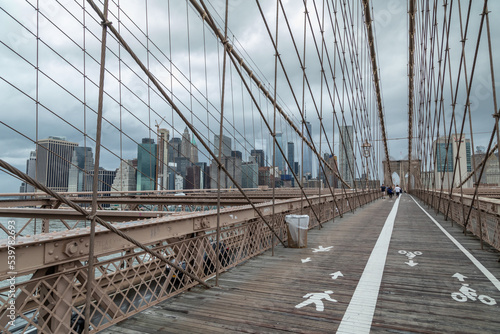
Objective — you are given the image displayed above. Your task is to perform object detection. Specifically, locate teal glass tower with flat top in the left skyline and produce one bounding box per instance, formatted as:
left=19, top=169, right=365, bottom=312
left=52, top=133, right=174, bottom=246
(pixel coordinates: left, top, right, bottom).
left=137, top=138, right=157, bottom=191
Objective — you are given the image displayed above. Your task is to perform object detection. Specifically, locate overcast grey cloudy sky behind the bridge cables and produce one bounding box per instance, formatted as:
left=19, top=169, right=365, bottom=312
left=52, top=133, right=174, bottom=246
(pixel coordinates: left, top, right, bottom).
left=0, top=0, right=500, bottom=193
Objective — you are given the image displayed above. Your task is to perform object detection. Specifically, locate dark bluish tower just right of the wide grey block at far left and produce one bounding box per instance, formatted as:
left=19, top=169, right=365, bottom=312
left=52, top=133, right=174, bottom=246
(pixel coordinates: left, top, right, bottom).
left=68, top=147, right=94, bottom=192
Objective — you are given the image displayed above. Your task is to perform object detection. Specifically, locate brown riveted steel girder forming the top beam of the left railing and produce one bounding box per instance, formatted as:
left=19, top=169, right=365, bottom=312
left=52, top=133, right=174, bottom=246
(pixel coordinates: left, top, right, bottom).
left=0, top=192, right=368, bottom=278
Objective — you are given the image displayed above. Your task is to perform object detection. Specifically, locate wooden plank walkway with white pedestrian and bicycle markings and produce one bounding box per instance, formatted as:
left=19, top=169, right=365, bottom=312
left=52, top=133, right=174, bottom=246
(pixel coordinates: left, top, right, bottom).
left=102, top=194, right=500, bottom=334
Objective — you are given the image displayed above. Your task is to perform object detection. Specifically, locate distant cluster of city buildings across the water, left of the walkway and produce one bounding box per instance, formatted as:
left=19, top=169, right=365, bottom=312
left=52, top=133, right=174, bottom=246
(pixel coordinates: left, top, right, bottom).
left=20, top=122, right=346, bottom=193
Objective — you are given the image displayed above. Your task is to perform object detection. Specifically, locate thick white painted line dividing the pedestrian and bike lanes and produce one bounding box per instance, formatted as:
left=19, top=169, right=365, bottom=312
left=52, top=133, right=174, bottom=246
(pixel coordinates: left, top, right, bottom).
left=337, top=197, right=400, bottom=334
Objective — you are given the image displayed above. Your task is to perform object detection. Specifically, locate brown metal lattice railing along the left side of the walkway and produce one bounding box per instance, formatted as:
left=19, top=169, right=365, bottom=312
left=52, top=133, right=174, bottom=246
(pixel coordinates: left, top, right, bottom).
left=0, top=190, right=380, bottom=333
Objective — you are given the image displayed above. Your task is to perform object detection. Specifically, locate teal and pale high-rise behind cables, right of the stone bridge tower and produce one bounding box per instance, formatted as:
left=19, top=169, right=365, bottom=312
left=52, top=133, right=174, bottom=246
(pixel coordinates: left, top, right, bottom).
left=434, top=134, right=472, bottom=188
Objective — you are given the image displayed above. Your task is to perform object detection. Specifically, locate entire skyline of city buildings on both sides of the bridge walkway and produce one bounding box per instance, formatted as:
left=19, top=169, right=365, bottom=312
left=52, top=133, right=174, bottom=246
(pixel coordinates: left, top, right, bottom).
left=19, top=126, right=496, bottom=192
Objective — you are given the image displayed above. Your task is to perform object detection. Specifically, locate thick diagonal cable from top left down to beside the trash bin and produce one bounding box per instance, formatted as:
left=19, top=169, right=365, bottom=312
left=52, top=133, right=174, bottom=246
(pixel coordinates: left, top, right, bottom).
left=87, top=0, right=286, bottom=247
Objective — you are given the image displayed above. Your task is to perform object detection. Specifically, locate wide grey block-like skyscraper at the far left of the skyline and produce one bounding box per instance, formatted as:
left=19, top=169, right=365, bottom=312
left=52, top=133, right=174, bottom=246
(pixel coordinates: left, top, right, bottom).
left=36, top=136, right=78, bottom=192
